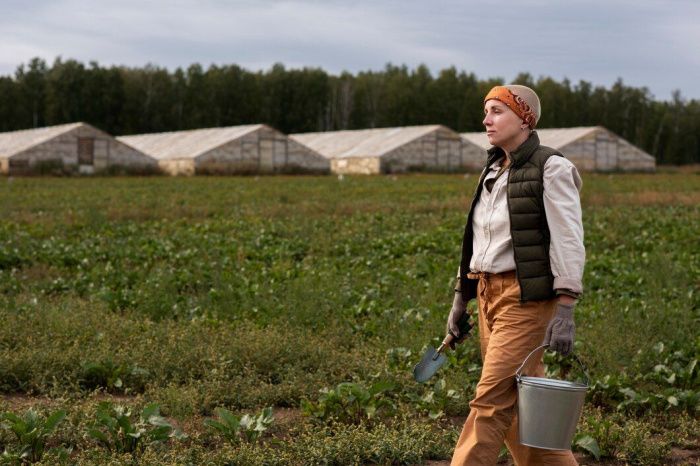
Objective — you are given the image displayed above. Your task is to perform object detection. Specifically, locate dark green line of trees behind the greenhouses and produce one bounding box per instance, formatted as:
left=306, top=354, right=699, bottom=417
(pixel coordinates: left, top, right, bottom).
left=0, top=57, right=700, bottom=164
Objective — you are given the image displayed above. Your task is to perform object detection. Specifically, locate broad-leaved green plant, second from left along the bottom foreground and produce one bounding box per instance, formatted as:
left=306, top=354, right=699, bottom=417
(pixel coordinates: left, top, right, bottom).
left=87, top=401, right=186, bottom=456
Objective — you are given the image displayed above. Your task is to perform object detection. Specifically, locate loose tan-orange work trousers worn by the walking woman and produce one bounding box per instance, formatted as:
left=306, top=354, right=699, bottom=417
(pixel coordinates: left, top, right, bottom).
left=451, top=272, right=578, bottom=466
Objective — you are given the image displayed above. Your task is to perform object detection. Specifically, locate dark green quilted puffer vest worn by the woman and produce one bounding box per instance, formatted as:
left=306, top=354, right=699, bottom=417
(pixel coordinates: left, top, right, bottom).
left=460, top=131, right=562, bottom=302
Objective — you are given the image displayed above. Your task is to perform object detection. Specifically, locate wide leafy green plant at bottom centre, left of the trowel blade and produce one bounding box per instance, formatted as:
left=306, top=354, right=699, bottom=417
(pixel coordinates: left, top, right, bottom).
left=302, top=381, right=396, bottom=423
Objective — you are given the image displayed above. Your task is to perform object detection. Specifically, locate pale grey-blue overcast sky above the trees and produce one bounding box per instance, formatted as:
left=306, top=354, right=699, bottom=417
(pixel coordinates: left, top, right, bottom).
left=0, top=0, right=700, bottom=100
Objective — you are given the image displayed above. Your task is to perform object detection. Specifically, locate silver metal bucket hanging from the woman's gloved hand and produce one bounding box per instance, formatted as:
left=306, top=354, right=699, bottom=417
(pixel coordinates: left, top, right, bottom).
left=515, top=345, right=590, bottom=450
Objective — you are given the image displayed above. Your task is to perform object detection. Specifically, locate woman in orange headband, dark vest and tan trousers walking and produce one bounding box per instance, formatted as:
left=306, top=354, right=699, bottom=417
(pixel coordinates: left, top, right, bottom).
left=447, top=85, right=585, bottom=466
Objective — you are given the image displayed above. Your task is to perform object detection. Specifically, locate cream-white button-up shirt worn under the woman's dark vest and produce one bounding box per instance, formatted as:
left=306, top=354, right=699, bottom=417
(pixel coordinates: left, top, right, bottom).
left=469, top=156, right=586, bottom=293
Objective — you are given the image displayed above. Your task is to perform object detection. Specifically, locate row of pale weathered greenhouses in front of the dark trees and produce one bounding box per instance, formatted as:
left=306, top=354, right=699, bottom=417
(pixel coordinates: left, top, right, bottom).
left=0, top=122, right=656, bottom=176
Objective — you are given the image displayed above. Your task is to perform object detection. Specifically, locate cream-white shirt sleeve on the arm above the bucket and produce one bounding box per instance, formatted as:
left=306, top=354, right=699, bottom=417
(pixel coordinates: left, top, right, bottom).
left=543, top=156, right=586, bottom=294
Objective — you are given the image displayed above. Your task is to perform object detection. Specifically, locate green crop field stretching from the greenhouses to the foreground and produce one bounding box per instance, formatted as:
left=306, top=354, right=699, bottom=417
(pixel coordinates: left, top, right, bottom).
left=0, top=173, right=700, bottom=465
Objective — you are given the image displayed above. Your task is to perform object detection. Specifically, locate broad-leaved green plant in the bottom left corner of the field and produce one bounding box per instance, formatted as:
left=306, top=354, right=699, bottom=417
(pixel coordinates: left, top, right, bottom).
left=0, top=409, right=66, bottom=463
